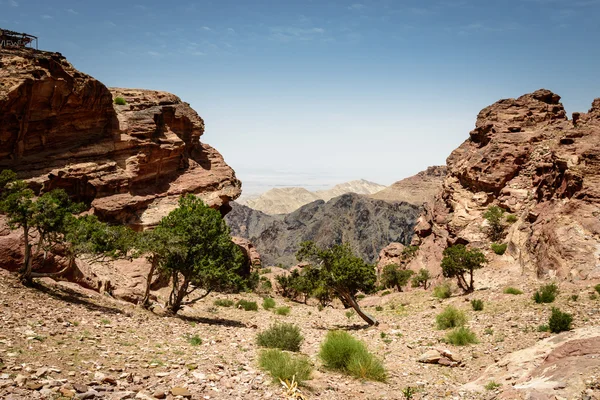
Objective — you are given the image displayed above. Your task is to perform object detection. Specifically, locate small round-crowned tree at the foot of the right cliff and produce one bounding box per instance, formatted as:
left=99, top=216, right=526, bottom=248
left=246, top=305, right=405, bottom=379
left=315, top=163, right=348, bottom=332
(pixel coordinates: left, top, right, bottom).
left=442, top=244, right=486, bottom=293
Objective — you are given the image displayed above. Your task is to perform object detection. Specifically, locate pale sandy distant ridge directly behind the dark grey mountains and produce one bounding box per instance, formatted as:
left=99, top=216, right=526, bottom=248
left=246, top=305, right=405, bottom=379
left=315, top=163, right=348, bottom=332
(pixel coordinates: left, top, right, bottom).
left=238, top=179, right=385, bottom=215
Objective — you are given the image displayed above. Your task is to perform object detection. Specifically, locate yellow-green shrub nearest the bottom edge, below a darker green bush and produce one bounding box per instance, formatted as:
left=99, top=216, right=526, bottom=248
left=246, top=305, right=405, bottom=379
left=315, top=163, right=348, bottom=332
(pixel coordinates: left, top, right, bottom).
left=258, top=349, right=312, bottom=384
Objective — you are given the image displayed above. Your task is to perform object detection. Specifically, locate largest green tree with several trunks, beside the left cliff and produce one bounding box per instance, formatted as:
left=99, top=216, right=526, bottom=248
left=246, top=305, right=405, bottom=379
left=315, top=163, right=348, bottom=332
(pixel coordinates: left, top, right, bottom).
left=155, top=195, right=244, bottom=313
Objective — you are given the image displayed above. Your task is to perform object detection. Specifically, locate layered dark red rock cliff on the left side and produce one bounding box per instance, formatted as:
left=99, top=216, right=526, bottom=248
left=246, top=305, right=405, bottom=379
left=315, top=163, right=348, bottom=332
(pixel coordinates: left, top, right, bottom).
left=0, top=49, right=241, bottom=229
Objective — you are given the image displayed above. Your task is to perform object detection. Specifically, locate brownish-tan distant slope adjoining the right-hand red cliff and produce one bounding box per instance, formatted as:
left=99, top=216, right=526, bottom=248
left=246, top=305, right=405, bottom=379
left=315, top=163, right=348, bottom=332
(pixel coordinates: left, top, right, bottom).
left=370, top=166, right=446, bottom=204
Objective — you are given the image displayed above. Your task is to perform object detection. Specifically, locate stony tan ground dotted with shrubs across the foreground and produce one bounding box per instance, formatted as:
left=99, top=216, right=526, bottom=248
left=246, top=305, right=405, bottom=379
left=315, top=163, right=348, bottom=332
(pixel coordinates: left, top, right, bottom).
left=0, top=270, right=600, bottom=400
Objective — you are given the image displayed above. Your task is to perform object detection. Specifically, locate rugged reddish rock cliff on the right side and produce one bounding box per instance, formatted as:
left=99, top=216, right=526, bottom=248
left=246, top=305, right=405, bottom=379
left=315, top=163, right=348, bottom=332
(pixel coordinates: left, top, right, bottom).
left=412, top=90, right=600, bottom=280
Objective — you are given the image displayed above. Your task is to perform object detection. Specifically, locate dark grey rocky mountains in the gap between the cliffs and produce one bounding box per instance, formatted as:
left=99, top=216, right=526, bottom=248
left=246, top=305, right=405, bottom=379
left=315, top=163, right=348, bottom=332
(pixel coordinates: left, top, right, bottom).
left=226, top=193, right=421, bottom=266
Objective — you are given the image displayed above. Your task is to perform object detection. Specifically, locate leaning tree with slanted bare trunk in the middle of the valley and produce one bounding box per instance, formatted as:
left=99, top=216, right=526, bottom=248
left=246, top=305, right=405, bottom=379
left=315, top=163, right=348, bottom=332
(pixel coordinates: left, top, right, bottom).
left=296, top=242, right=378, bottom=325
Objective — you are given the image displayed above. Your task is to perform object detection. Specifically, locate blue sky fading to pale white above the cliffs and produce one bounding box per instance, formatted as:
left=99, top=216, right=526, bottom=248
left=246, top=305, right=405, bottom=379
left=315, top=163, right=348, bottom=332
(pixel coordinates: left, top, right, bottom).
left=0, top=0, right=600, bottom=192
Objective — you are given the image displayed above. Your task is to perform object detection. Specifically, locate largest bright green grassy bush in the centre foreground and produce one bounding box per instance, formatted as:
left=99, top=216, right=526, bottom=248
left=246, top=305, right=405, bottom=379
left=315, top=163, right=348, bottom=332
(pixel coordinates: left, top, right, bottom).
left=319, top=331, right=387, bottom=382
